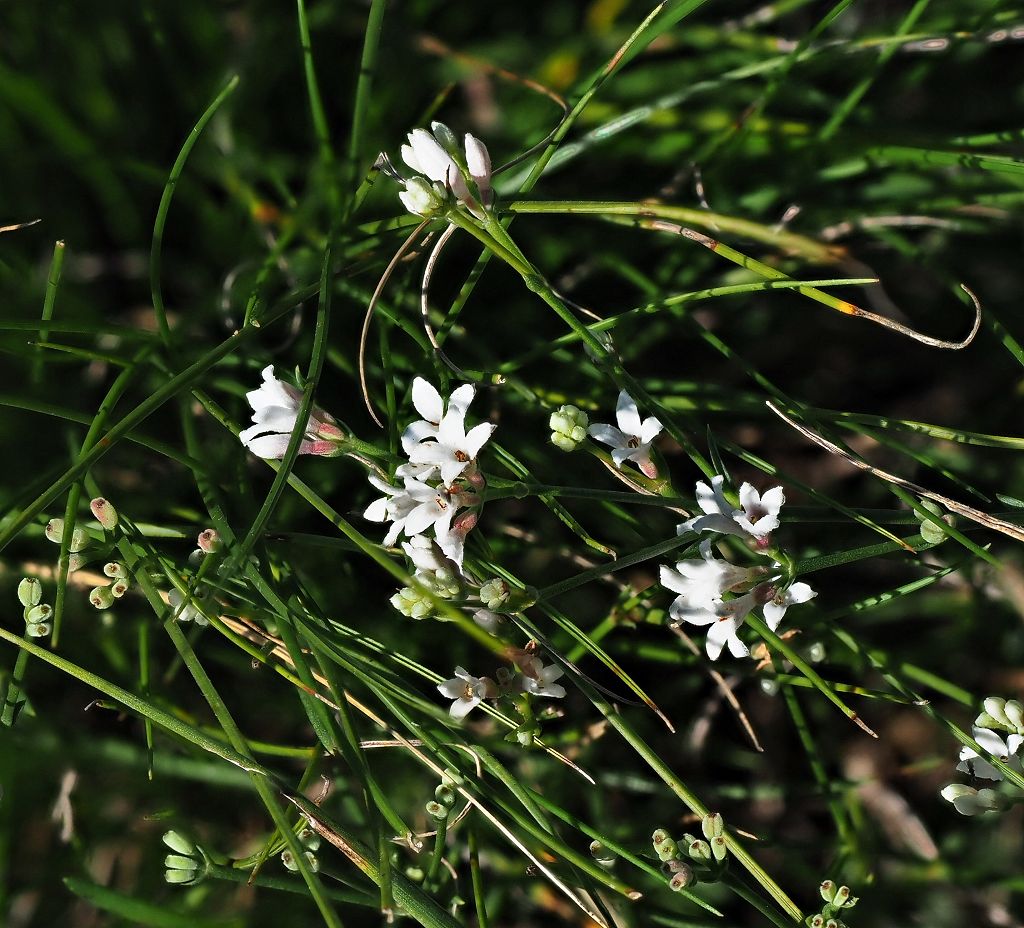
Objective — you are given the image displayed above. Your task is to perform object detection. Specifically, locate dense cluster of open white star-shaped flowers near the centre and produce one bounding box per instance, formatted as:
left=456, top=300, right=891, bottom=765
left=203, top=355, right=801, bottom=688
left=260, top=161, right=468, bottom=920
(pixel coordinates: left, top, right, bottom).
left=362, top=377, right=495, bottom=571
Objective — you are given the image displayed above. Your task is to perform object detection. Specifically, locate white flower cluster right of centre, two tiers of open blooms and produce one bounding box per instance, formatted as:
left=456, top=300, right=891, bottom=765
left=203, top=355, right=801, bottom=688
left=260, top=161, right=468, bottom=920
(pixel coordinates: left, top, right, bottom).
left=660, top=476, right=817, bottom=661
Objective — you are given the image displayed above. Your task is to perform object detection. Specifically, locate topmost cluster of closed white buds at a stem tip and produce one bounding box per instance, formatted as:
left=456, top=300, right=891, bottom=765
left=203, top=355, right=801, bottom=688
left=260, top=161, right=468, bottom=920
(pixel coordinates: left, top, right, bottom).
left=392, top=122, right=494, bottom=218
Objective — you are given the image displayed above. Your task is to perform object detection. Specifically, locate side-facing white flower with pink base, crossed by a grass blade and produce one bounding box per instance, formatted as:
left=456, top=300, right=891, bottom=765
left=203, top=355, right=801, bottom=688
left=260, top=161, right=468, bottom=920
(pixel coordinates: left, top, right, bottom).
left=239, top=365, right=342, bottom=460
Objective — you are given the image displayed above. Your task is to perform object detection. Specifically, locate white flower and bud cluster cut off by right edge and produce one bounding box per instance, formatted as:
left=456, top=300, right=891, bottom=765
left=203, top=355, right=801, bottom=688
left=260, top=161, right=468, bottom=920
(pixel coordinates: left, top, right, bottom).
left=940, top=697, right=1024, bottom=815
